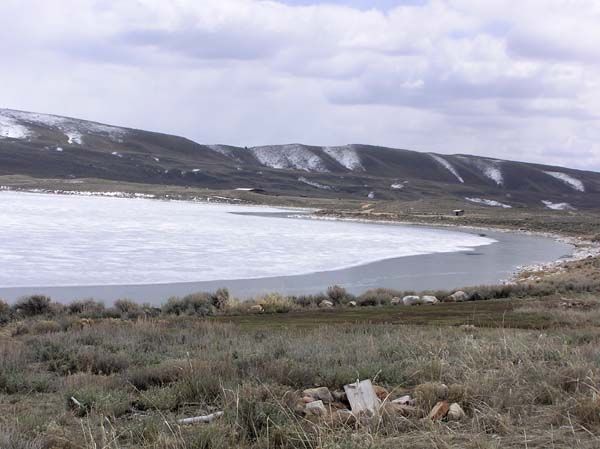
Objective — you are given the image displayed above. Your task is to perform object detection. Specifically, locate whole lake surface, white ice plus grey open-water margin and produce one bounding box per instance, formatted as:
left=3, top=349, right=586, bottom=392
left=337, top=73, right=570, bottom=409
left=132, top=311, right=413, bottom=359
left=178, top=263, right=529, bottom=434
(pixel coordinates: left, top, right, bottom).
left=0, top=192, right=571, bottom=303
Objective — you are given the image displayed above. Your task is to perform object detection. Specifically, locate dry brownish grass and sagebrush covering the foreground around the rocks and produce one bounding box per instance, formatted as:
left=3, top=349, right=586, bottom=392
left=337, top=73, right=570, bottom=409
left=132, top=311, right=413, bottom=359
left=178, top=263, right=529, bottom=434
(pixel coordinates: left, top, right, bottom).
left=0, top=310, right=600, bottom=449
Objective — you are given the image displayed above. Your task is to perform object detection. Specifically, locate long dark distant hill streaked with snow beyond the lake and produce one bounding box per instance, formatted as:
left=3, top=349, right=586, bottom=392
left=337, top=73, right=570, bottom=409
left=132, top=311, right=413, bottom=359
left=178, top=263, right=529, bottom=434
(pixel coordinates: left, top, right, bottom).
left=0, top=109, right=600, bottom=209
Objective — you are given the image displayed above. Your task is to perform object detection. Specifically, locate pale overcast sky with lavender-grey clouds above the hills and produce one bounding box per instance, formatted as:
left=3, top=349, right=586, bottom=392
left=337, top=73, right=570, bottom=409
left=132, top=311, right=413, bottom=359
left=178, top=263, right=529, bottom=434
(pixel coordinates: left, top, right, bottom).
left=0, top=0, right=600, bottom=170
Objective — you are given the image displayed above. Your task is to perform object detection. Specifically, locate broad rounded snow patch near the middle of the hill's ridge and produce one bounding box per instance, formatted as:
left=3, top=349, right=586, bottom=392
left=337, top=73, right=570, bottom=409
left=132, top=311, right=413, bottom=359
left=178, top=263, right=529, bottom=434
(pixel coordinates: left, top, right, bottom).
left=250, top=144, right=329, bottom=173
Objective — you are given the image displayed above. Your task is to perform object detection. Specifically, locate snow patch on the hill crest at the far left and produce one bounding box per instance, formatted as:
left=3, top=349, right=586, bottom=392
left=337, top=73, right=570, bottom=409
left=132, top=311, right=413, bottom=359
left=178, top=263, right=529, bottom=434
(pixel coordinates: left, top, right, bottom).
left=0, top=109, right=127, bottom=145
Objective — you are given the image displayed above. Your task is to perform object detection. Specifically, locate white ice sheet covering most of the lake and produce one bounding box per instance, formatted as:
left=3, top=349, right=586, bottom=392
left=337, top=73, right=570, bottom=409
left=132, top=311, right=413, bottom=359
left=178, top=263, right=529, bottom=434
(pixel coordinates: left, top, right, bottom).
left=0, top=191, right=494, bottom=287
